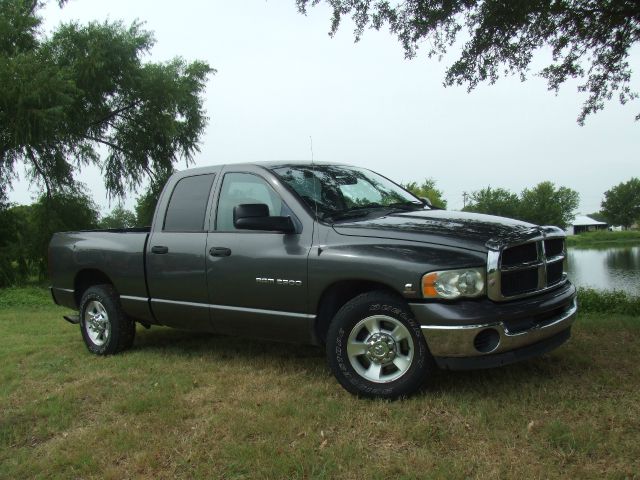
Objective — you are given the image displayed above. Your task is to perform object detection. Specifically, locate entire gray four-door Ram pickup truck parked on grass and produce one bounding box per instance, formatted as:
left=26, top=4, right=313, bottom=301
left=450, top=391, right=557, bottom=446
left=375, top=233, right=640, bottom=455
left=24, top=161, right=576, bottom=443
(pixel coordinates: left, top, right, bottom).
left=49, top=162, right=576, bottom=398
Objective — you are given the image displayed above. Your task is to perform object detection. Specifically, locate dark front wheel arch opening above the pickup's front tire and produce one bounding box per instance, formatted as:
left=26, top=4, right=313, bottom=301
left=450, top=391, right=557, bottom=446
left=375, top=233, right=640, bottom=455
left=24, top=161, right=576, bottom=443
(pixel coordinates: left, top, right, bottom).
left=314, top=279, right=404, bottom=345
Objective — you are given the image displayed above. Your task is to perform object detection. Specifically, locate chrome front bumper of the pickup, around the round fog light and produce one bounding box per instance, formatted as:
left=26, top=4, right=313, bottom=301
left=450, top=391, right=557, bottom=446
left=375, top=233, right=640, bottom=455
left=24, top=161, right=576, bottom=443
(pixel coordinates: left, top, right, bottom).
left=421, top=298, right=577, bottom=357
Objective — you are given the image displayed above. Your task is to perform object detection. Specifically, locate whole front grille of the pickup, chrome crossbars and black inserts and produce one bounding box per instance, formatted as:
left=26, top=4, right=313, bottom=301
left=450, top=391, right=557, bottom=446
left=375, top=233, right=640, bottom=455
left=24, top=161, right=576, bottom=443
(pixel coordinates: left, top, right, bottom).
left=487, top=237, right=566, bottom=301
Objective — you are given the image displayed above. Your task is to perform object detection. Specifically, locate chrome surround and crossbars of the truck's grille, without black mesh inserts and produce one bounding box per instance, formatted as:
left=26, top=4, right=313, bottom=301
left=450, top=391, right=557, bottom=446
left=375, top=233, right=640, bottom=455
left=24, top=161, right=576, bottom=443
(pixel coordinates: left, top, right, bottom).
left=487, top=227, right=567, bottom=302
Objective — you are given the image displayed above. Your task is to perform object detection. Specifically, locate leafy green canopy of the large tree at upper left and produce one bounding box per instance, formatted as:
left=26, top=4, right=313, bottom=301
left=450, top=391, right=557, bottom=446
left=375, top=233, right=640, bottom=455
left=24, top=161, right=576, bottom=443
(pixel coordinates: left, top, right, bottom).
left=0, top=0, right=213, bottom=196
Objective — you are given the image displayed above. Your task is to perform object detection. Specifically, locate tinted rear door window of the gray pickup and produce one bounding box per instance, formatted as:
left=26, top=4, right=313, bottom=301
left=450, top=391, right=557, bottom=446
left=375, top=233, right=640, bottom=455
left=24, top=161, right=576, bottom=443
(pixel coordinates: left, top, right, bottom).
left=164, top=174, right=214, bottom=232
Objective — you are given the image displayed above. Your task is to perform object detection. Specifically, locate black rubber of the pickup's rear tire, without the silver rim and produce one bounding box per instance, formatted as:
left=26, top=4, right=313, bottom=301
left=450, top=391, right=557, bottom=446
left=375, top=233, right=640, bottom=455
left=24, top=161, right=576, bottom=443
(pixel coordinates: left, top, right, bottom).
left=80, top=286, right=127, bottom=355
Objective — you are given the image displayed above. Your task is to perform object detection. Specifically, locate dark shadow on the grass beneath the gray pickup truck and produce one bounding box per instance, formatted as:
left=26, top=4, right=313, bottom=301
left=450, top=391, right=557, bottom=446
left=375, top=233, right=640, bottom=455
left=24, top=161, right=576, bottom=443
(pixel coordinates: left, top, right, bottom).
left=134, top=327, right=583, bottom=398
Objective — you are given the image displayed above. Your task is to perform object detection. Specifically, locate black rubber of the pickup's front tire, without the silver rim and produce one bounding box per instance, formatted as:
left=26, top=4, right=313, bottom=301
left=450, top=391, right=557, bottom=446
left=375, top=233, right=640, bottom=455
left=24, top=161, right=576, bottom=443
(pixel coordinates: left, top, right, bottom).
left=327, top=292, right=432, bottom=399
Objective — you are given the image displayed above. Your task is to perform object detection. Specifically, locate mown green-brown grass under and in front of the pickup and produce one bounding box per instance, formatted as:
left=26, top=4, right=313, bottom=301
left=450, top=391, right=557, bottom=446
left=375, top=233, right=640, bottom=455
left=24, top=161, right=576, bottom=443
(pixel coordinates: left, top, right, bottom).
left=0, top=288, right=640, bottom=479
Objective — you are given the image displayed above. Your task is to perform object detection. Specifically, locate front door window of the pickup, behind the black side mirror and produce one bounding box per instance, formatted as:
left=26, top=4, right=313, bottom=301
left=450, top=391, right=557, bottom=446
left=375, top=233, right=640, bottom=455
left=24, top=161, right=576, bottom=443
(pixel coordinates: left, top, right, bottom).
left=216, top=173, right=283, bottom=231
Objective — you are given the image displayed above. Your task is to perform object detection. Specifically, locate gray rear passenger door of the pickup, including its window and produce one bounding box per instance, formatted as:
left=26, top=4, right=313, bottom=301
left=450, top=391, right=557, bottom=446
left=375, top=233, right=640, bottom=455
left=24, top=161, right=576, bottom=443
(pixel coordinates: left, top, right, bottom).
left=146, top=173, right=215, bottom=330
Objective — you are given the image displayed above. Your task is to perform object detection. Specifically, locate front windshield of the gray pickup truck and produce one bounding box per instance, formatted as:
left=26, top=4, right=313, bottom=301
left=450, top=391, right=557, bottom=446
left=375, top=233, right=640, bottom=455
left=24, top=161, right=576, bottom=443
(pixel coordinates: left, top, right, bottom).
left=273, top=165, right=424, bottom=221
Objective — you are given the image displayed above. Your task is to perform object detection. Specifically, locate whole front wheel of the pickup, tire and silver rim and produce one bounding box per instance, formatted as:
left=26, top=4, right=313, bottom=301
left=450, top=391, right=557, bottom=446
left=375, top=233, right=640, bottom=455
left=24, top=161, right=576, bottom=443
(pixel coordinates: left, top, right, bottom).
left=327, top=291, right=434, bottom=399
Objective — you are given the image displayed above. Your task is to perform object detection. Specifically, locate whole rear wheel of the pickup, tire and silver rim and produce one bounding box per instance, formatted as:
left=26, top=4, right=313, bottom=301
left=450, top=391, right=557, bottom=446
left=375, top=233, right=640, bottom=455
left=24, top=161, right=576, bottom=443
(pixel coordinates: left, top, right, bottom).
left=80, top=285, right=136, bottom=355
